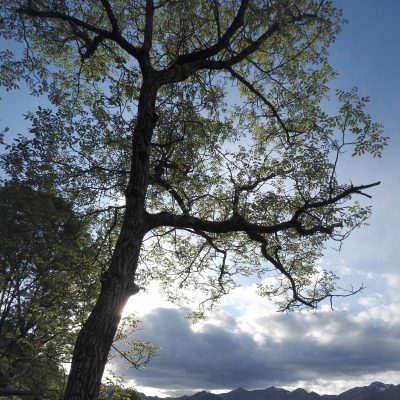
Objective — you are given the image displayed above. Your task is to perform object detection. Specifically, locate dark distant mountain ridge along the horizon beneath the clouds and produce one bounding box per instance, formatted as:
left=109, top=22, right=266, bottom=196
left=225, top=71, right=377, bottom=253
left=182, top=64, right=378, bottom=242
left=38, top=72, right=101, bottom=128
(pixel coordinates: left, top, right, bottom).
left=140, top=382, right=400, bottom=400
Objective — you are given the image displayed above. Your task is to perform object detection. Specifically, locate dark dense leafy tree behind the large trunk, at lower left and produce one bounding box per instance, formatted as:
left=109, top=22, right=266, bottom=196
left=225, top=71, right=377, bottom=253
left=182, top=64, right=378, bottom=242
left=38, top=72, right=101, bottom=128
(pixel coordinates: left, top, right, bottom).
left=0, top=181, right=99, bottom=399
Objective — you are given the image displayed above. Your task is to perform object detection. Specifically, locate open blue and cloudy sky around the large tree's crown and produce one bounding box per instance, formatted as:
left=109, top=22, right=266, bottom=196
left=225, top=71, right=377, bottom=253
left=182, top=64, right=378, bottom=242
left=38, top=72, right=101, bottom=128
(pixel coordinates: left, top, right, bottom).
left=0, top=0, right=400, bottom=396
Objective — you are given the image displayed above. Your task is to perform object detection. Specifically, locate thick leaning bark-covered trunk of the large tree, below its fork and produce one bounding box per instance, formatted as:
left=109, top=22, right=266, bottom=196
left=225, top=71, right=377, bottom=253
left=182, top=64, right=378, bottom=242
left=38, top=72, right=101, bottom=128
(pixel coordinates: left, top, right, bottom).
left=64, top=75, right=158, bottom=400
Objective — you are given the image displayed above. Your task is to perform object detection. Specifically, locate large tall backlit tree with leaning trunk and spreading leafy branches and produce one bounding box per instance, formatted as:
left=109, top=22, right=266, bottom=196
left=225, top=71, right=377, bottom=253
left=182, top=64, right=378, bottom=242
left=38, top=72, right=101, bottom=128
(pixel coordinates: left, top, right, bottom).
left=1, top=0, right=386, bottom=399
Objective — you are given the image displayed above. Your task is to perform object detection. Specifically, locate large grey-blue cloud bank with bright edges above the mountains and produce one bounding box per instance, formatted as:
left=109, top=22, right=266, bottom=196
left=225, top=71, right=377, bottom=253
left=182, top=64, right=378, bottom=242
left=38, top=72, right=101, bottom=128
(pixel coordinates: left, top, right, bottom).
left=114, top=305, right=400, bottom=393
